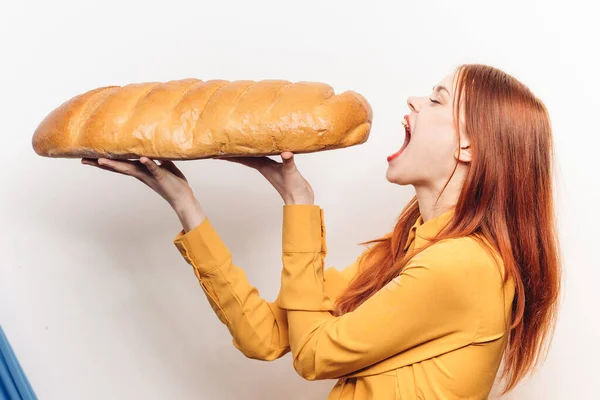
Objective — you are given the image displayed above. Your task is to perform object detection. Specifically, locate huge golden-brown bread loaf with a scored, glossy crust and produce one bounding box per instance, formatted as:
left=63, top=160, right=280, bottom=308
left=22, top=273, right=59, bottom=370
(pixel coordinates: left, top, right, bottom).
left=32, top=79, right=372, bottom=160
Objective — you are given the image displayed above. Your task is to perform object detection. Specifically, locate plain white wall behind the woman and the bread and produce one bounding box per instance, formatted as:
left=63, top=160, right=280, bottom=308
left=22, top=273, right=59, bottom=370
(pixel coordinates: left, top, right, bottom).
left=0, top=0, right=600, bottom=400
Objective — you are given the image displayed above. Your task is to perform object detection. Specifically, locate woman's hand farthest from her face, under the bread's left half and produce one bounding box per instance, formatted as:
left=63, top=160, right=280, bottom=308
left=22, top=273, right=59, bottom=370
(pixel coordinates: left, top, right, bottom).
left=81, top=157, right=195, bottom=211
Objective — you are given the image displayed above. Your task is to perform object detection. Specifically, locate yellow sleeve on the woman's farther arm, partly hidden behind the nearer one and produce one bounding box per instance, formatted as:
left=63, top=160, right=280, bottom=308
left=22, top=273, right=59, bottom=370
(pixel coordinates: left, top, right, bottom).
left=173, top=217, right=356, bottom=361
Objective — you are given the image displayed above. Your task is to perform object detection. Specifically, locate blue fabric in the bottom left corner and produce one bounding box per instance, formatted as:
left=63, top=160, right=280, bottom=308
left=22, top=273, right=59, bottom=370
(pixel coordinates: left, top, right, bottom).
left=0, top=326, right=37, bottom=400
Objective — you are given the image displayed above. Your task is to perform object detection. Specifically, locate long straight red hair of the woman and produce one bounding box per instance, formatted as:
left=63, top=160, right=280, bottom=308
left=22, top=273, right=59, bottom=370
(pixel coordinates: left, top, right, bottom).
left=335, top=64, right=561, bottom=394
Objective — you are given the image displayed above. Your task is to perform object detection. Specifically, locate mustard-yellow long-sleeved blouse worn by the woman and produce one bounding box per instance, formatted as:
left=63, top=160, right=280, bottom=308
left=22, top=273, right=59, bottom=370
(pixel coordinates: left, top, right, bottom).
left=174, top=204, right=514, bottom=400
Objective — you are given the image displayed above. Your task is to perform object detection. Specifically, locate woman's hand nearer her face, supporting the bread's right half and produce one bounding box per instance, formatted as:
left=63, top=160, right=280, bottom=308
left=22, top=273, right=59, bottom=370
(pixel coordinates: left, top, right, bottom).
left=215, top=151, right=314, bottom=204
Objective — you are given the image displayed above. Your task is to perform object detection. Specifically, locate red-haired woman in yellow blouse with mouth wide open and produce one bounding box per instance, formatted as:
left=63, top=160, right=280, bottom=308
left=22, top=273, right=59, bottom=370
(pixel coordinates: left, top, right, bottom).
left=82, top=65, right=560, bottom=400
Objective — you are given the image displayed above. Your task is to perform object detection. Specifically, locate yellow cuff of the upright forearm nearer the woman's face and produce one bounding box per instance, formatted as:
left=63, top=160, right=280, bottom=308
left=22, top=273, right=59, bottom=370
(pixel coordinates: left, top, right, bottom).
left=282, top=204, right=327, bottom=254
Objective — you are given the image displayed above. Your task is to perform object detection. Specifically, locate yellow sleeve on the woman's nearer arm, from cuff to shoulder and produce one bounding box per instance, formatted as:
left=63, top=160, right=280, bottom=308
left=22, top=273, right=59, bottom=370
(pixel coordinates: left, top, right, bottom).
left=279, top=205, right=478, bottom=380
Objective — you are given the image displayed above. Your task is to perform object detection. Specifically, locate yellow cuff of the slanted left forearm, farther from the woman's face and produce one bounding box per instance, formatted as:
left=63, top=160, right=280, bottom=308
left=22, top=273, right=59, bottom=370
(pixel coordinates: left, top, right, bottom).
left=173, top=217, right=231, bottom=275
